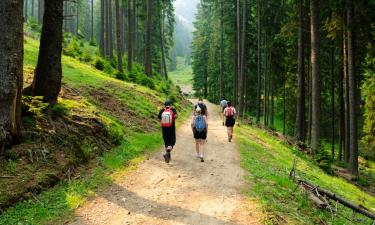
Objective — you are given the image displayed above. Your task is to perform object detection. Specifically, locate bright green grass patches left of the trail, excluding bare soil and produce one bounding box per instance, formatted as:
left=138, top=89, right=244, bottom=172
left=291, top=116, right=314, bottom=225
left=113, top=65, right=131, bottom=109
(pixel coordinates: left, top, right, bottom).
left=0, top=34, right=190, bottom=225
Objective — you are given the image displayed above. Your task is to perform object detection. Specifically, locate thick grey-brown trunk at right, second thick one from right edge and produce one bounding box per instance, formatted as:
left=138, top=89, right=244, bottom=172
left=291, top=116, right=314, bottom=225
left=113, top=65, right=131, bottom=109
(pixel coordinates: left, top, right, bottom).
left=310, top=0, right=320, bottom=155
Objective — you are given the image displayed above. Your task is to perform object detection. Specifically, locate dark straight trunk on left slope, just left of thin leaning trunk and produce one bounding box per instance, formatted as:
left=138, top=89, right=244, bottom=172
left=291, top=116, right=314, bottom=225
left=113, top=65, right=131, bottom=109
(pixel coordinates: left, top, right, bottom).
left=145, top=0, right=152, bottom=77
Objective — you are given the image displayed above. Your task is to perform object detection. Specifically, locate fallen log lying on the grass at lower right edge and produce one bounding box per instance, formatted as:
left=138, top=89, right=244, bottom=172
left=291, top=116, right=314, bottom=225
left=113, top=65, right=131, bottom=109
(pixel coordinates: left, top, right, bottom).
left=298, top=180, right=375, bottom=220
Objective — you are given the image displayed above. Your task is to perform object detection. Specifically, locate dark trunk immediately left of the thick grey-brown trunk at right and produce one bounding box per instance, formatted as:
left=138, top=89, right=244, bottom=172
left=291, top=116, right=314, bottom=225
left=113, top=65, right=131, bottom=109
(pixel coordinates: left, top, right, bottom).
left=295, top=0, right=305, bottom=141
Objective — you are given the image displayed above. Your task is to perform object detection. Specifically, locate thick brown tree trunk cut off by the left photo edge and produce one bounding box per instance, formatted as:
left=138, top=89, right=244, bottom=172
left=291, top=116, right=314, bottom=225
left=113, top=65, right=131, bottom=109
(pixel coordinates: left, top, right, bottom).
left=0, top=0, right=23, bottom=156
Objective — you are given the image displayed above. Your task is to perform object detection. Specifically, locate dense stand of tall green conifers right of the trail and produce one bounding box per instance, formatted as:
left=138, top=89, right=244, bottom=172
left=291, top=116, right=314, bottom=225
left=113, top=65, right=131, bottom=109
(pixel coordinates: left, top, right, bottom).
left=192, top=0, right=375, bottom=175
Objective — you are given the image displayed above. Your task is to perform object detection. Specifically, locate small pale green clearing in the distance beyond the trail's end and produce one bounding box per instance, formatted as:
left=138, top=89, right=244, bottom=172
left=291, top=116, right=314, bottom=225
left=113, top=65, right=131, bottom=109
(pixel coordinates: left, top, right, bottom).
left=169, top=57, right=193, bottom=87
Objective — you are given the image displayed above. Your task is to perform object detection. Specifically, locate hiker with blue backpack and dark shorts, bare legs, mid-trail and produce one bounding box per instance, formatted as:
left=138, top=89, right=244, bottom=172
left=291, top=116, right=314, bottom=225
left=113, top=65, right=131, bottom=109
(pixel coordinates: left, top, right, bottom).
left=191, top=106, right=208, bottom=162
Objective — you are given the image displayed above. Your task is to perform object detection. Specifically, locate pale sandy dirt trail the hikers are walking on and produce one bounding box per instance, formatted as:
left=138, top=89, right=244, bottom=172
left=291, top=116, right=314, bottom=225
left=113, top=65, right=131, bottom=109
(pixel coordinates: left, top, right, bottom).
left=71, top=103, right=263, bottom=225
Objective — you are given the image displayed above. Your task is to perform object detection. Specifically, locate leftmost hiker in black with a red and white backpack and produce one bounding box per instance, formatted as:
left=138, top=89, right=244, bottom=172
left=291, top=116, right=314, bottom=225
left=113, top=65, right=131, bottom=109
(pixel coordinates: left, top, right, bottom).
left=158, top=100, right=177, bottom=163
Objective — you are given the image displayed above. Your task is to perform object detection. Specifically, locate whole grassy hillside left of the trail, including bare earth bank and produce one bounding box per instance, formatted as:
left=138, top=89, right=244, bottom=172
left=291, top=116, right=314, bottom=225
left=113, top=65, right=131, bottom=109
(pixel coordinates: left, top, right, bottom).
left=0, top=35, right=190, bottom=224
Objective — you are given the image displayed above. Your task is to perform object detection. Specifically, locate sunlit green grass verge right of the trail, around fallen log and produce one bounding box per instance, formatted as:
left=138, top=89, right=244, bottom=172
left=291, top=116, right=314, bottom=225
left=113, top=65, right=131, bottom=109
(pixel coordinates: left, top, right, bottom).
left=236, top=126, right=375, bottom=224
